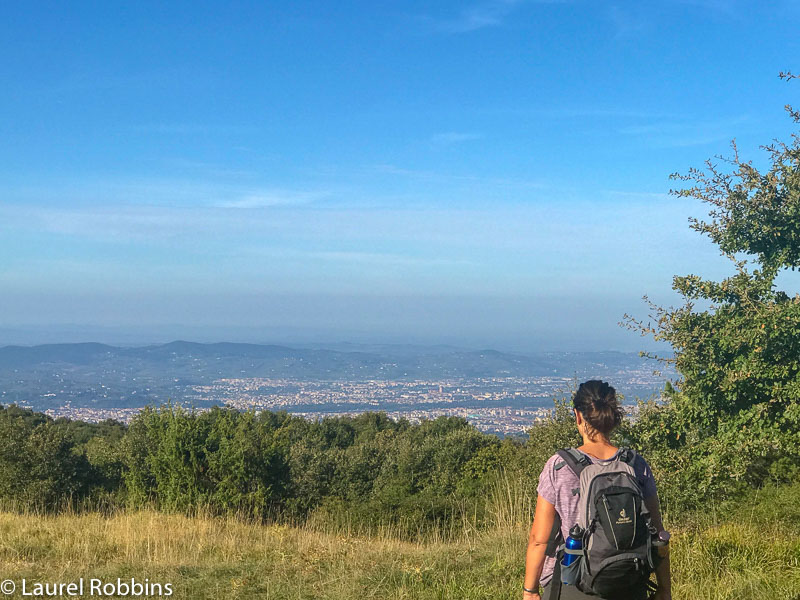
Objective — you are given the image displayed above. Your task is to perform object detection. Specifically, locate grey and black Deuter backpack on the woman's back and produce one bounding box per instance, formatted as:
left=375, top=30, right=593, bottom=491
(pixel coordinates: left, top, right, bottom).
left=549, top=448, right=657, bottom=600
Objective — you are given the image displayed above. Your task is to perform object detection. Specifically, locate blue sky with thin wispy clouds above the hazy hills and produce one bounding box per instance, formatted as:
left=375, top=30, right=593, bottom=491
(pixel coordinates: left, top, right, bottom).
left=0, top=0, right=800, bottom=350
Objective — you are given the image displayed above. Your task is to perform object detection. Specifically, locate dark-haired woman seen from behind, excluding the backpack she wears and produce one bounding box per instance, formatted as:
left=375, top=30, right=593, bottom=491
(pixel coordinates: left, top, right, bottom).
left=523, top=380, right=672, bottom=600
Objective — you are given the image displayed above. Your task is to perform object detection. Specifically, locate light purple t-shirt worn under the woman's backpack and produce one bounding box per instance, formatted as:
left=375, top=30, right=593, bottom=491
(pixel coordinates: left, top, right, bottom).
left=537, top=450, right=656, bottom=585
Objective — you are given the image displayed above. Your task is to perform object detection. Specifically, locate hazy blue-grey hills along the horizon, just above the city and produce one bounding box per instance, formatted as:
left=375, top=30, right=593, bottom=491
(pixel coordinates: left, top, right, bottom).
left=0, top=340, right=676, bottom=410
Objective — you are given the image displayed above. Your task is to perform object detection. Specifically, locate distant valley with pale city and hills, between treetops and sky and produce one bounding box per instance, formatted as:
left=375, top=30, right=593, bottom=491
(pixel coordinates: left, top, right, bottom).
left=0, top=342, right=675, bottom=435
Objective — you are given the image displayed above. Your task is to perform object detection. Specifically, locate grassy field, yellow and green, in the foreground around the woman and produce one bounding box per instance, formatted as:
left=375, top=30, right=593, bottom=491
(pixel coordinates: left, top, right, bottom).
left=0, top=485, right=800, bottom=600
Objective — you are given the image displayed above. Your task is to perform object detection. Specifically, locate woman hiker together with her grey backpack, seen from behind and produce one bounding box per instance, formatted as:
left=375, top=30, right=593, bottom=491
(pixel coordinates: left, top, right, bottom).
left=522, top=380, right=671, bottom=600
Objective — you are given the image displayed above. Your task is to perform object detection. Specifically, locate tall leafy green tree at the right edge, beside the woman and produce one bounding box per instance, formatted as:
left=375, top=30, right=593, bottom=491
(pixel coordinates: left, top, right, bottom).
left=626, top=74, right=800, bottom=502
